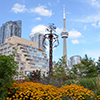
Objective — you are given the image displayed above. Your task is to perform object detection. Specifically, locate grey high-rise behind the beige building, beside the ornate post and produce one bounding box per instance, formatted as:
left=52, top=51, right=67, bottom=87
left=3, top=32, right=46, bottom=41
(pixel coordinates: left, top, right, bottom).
left=30, top=33, right=45, bottom=51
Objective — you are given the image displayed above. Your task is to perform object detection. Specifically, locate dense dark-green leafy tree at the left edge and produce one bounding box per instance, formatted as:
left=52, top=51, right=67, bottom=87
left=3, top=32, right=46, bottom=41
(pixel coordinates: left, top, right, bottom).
left=0, top=55, right=18, bottom=100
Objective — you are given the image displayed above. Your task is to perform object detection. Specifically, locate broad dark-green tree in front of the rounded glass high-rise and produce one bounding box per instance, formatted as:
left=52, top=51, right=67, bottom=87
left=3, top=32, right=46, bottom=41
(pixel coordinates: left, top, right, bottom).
left=71, top=55, right=97, bottom=78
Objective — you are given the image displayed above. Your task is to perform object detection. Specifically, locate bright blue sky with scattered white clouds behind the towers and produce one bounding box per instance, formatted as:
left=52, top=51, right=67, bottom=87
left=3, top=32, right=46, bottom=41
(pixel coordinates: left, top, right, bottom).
left=0, top=0, right=100, bottom=61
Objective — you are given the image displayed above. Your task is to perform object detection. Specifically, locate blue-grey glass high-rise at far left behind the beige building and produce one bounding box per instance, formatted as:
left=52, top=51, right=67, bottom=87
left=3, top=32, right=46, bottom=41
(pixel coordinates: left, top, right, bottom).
left=0, top=20, right=22, bottom=44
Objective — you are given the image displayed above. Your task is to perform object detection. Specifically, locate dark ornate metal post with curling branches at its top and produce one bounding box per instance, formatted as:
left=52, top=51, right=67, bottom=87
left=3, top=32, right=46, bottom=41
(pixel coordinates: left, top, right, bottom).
left=43, top=23, right=59, bottom=81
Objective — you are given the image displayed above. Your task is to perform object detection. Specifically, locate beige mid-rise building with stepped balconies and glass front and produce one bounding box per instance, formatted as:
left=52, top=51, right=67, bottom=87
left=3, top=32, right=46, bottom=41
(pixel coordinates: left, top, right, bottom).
left=0, top=36, right=49, bottom=80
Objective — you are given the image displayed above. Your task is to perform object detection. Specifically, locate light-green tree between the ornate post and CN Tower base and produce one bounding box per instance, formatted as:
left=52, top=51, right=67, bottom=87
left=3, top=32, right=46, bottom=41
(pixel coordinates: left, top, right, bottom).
left=53, top=56, right=68, bottom=81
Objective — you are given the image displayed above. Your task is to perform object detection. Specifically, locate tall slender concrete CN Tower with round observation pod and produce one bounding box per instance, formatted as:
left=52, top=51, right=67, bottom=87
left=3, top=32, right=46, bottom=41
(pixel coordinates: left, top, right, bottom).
left=61, top=5, right=68, bottom=62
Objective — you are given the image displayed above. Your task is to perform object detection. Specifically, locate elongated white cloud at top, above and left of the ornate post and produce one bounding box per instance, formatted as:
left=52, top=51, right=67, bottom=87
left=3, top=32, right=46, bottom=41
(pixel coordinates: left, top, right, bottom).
left=29, top=5, right=52, bottom=17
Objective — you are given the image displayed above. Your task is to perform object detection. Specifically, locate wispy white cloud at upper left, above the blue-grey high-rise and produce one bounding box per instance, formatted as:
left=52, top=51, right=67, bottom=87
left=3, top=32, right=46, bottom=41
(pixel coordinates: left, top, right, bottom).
left=11, top=3, right=27, bottom=13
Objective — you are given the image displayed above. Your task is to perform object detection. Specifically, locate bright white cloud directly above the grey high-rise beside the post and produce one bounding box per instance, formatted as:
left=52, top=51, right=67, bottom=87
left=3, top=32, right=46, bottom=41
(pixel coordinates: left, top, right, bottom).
left=30, top=25, right=47, bottom=35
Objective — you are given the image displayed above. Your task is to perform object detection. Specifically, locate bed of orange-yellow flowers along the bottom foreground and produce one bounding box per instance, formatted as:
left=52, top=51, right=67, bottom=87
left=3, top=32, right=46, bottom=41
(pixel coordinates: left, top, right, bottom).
left=6, top=82, right=99, bottom=100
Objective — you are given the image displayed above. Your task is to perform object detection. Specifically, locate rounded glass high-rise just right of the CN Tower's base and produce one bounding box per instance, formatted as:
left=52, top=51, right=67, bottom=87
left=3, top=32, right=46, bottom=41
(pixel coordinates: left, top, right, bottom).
left=68, top=55, right=81, bottom=68
